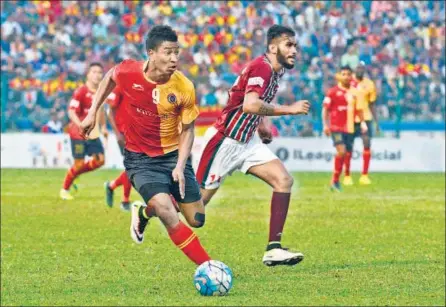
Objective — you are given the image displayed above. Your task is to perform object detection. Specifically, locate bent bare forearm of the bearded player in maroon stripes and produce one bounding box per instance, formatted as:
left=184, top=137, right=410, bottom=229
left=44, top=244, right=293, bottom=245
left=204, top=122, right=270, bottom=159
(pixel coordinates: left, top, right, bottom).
left=243, top=92, right=310, bottom=116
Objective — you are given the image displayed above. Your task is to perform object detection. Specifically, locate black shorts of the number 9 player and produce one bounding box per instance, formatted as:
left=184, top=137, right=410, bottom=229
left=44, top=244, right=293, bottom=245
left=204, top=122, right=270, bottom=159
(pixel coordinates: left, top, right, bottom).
left=124, top=150, right=201, bottom=204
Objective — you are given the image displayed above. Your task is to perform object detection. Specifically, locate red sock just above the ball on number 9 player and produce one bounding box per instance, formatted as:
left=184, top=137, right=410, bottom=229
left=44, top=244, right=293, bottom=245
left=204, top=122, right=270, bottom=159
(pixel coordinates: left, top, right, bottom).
left=167, top=221, right=211, bottom=265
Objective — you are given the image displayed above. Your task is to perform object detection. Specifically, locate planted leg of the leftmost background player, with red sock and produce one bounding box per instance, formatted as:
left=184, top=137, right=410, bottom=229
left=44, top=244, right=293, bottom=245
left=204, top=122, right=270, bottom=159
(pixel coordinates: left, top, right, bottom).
left=59, top=139, right=86, bottom=200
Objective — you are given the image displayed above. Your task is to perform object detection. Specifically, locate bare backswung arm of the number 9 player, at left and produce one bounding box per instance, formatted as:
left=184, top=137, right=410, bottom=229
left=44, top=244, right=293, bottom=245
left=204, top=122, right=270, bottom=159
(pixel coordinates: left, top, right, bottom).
left=81, top=66, right=116, bottom=138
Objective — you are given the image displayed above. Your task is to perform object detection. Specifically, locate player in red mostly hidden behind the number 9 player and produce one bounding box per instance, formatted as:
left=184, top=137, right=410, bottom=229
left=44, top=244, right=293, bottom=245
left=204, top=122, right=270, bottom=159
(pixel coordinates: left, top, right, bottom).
left=104, top=87, right=132, bottom=211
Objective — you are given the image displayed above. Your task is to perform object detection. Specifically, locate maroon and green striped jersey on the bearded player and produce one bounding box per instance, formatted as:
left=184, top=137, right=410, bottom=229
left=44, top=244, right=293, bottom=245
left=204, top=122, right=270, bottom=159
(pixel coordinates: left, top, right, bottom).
left=214, top=55, right=285, bottom=143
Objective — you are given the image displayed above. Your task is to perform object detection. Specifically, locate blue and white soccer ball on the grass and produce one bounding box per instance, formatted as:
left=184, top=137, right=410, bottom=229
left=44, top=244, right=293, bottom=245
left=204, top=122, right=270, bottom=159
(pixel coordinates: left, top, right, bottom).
left=194, top=260, right=232, bottom=296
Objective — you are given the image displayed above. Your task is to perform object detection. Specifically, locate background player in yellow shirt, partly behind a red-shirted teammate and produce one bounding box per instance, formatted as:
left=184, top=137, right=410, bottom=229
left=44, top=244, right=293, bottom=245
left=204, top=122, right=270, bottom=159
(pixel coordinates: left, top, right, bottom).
left=343, top=62, right=379, bottom=185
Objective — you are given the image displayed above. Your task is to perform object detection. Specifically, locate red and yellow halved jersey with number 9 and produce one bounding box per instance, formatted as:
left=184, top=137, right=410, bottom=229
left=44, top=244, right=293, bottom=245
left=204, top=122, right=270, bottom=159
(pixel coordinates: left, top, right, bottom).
left=112, top=60, right=199, bottom=157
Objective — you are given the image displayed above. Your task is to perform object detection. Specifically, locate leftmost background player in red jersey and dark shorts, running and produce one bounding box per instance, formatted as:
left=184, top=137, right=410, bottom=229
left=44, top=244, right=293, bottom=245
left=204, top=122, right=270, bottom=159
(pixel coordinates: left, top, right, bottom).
left=59, top=63, right=107, bottom=200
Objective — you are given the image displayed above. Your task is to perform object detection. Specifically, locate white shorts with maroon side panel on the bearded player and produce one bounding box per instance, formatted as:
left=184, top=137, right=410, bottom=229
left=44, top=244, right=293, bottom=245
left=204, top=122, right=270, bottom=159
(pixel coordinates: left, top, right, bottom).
left=197, top=127, right=278, bottom=190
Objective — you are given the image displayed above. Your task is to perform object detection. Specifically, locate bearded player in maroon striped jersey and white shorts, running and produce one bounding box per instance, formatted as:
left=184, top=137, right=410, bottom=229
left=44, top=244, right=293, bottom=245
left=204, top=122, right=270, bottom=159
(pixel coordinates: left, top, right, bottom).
left=197, top=25, right=310, bottom=266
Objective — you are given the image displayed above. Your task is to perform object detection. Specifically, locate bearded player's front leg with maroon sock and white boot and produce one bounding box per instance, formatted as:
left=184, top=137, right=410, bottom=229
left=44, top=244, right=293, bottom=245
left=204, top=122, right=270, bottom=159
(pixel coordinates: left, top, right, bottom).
left=246, top=156, right=304, bottom=266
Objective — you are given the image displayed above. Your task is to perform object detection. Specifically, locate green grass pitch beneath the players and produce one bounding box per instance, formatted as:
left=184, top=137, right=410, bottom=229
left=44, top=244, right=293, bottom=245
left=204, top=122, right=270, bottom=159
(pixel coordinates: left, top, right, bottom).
left=1, top=170, right=445, bottom=306
